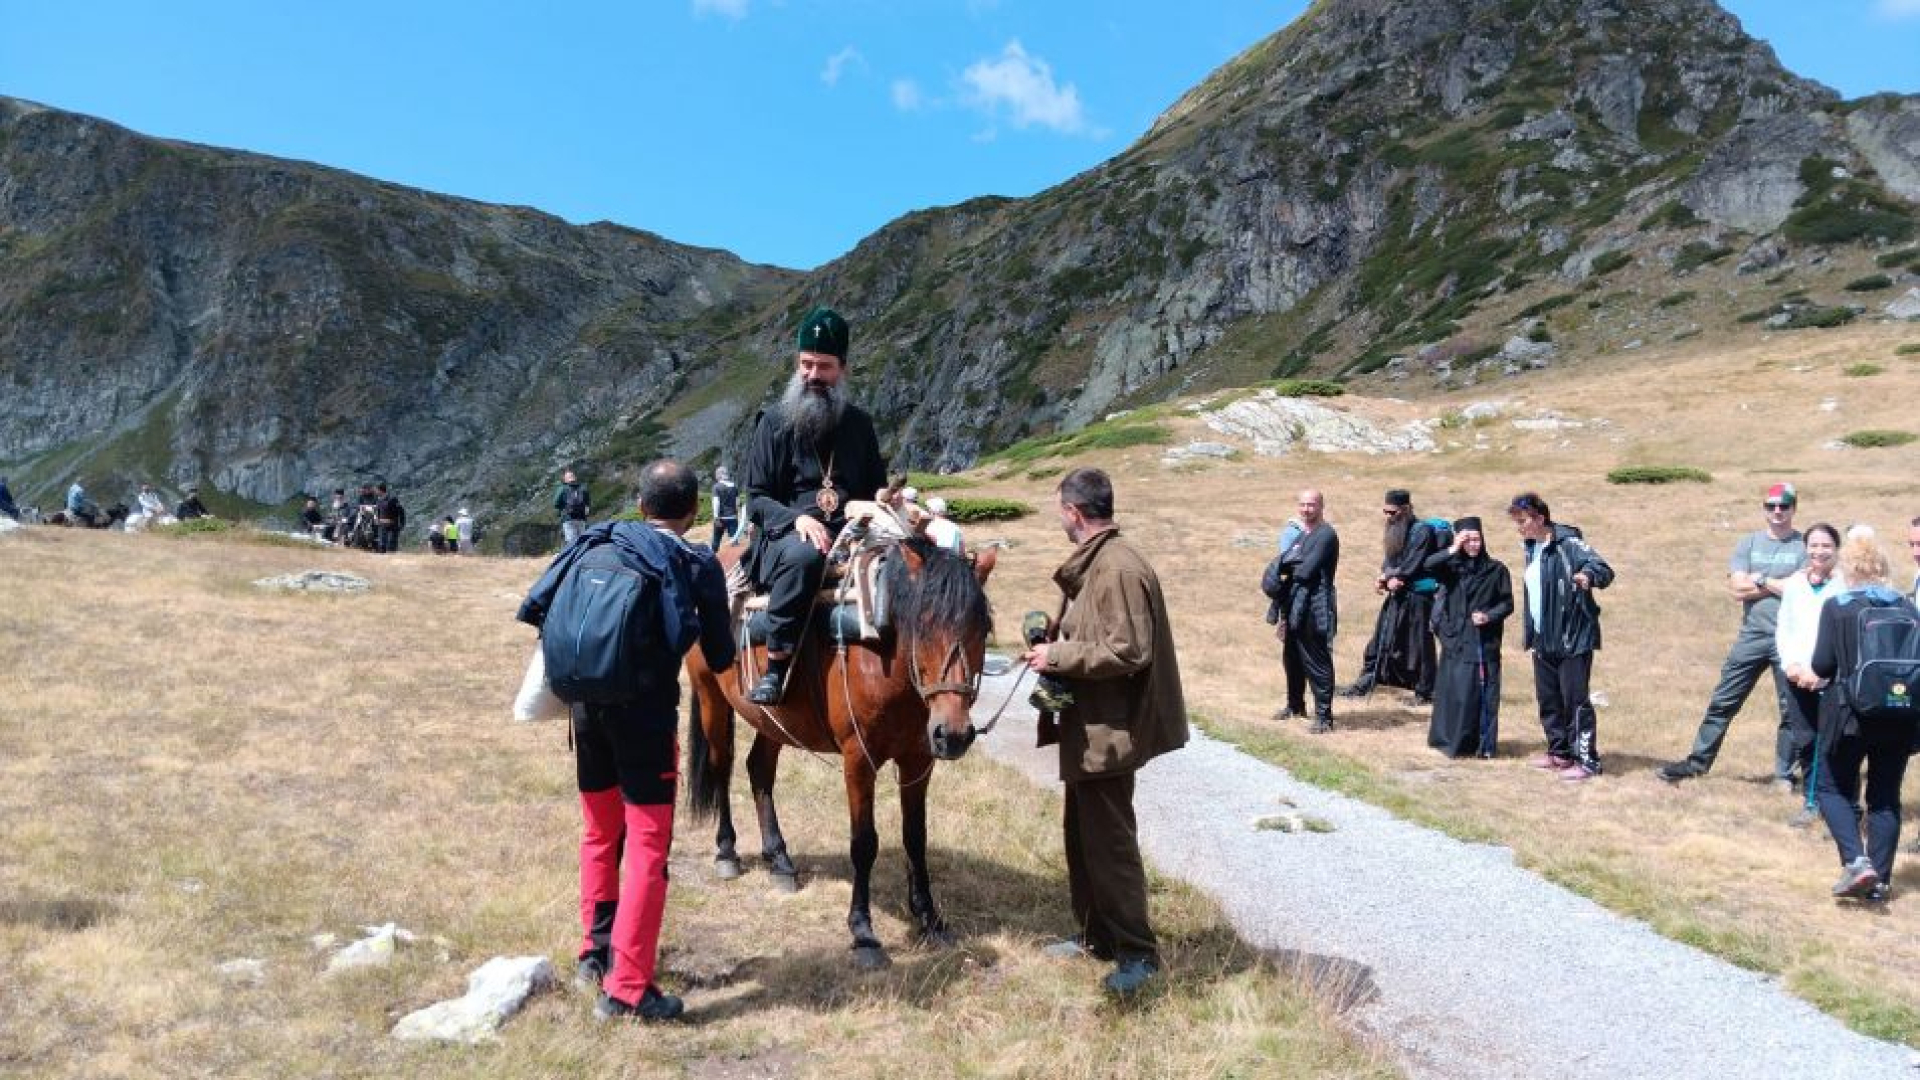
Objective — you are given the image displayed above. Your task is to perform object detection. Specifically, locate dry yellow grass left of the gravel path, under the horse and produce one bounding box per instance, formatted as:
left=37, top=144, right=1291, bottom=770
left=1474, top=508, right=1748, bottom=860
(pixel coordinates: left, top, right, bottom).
left=0, top=530, right=1394, bottom=1078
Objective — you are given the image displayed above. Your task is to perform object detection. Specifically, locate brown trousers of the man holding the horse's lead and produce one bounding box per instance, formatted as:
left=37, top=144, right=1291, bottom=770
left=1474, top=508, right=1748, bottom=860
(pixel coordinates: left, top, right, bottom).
left=1064, top=773, right=1160, bottom=963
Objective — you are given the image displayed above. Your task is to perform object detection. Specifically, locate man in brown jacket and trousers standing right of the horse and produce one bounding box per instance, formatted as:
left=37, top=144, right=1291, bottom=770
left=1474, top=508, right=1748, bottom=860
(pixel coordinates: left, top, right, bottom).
left=1025, top=469, right=1187, bottom=997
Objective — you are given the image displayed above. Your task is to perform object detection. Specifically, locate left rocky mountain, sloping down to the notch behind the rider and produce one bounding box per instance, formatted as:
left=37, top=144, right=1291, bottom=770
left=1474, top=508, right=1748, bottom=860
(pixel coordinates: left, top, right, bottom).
left=0, top=100, right=793, bottom=518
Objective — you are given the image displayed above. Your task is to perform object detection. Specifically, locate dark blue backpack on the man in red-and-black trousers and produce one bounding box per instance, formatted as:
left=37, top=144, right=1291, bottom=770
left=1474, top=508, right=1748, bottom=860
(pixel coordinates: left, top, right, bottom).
left=540, top=527, right=699, bottom=705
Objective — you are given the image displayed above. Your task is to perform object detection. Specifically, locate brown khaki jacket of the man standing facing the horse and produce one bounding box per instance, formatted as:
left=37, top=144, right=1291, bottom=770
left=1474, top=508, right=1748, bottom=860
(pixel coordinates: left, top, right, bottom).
left=1041, top=528, right=1187, bottom=784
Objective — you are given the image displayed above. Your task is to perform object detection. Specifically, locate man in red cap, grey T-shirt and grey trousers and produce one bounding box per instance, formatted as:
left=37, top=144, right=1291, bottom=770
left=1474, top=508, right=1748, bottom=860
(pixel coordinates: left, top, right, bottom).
left=1655, top=484, right=1812, bottom=790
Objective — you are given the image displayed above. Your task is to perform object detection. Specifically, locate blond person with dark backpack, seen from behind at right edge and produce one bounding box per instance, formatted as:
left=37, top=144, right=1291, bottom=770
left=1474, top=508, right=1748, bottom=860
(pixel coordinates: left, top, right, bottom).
left=1809, top=536, right=1920, bottom=901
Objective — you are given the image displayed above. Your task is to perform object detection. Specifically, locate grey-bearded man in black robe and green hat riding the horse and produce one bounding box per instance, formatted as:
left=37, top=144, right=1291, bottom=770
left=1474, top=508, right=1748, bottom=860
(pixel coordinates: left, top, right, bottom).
left=745, top=307, right=887, bottom=705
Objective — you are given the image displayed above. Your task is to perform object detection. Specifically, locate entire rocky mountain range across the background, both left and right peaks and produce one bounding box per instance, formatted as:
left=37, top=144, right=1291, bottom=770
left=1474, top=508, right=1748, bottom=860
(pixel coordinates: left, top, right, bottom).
left=0, top=0, right=1920, bottom=505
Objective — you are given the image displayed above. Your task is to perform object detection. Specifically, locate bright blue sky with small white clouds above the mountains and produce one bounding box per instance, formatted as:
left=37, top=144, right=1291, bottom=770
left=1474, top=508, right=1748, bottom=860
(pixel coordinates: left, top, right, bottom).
left=0, top=0, right=1920, bottom=267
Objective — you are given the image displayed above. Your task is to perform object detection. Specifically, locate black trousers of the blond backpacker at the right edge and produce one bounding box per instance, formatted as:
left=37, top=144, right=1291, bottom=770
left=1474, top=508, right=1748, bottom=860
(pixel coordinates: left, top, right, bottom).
left=1814, top=713, right=1914, bottom=882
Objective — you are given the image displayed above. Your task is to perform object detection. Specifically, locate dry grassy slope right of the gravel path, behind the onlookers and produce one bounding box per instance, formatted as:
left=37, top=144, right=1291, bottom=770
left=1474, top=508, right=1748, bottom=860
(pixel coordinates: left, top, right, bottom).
left=970, top=327, right=1920, bottom=1045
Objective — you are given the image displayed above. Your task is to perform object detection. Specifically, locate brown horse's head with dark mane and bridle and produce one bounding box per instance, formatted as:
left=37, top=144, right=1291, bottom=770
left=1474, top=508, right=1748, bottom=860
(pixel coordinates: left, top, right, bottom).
left=889, top=540, right=993, bottom=761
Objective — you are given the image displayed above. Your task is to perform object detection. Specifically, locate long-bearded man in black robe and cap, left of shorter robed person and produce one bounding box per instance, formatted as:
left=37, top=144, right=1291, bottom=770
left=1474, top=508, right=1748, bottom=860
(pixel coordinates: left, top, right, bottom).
left=1340, top=488, right=1453, bottom=705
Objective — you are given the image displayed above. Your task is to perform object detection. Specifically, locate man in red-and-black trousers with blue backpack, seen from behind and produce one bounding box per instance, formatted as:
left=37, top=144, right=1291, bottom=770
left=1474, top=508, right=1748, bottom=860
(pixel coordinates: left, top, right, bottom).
left=518, top=461, right=733, bottom=1020
